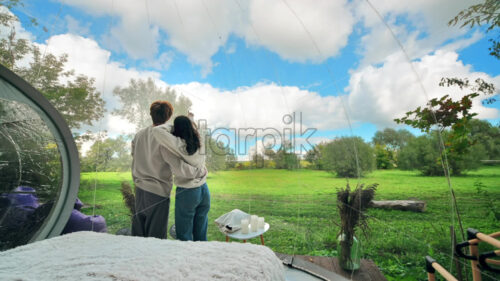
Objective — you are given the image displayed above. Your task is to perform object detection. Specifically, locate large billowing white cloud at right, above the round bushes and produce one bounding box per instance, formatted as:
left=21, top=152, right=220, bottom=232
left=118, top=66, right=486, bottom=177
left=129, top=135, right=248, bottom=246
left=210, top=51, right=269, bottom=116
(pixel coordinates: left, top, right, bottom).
left=347, top=50, right=500, bottom=126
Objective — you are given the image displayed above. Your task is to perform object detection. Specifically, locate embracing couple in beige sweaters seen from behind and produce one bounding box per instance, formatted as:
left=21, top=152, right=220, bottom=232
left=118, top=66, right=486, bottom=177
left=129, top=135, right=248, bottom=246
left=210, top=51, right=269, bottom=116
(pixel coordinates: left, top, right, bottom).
left=132, top=101, right=210, bottom=241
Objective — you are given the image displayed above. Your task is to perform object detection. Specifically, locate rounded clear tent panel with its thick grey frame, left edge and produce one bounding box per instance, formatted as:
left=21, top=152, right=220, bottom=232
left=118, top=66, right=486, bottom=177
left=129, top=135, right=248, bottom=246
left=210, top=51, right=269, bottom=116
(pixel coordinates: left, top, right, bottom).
left=0, top=65, right=80, bottom=250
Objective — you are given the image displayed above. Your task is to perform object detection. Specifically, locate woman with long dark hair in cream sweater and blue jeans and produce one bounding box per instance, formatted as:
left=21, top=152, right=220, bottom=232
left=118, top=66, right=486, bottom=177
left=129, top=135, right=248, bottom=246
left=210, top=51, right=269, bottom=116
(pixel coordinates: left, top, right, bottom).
left=153, top=116, right=210, bottom=241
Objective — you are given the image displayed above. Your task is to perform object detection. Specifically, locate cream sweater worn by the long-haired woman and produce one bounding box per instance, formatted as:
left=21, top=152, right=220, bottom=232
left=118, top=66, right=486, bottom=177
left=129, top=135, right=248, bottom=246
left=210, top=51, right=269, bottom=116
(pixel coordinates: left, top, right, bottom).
left=153, top=124, right=208, bottom=188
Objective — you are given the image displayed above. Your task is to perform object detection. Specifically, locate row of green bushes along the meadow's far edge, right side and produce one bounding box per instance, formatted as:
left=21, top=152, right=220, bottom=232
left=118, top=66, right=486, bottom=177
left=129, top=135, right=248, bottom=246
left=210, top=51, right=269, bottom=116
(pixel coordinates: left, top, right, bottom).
left=305, top=119, right=500, bottom=177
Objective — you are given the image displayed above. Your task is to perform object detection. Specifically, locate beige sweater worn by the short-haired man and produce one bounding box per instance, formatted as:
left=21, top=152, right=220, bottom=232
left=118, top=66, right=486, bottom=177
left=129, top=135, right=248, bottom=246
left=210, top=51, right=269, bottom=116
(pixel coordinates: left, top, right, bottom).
left=132, top=126, right=206, bottom=197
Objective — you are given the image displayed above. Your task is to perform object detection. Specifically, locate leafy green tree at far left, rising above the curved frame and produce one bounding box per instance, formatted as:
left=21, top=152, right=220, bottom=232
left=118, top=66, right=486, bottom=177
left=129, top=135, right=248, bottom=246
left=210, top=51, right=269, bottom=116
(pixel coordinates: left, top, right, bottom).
left=0, top=0, right=105, bottom=129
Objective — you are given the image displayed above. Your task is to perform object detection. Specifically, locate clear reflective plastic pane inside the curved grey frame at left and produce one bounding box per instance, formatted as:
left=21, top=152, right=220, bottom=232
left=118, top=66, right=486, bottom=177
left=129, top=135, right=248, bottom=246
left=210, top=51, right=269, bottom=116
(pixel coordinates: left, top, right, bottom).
left=0, top=79, right=62, bottom=250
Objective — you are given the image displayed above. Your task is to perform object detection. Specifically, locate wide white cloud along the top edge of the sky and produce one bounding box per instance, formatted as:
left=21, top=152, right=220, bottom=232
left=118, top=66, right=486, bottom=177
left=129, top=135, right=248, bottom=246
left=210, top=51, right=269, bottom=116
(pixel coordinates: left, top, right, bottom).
left=58, top=0, right=354, bottom=75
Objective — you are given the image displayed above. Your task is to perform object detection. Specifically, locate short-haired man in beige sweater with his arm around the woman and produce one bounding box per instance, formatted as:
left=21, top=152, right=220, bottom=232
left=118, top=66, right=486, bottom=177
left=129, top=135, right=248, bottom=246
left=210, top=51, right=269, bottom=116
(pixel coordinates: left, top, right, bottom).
left=132, top=101, right=206, bottom=239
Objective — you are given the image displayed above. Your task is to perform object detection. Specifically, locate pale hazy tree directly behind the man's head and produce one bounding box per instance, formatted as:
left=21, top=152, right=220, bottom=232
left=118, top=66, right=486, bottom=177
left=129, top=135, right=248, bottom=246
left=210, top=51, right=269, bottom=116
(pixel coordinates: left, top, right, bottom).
left=113, top=78, right=192, bottom=129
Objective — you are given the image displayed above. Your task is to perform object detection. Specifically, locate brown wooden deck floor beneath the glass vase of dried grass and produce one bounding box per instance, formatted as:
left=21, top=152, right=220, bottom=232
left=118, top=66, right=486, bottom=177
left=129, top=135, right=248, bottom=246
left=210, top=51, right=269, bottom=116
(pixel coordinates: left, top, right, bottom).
left=275, top=253, right=387, bottom=281
